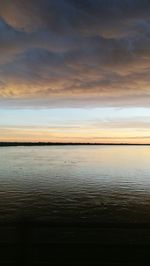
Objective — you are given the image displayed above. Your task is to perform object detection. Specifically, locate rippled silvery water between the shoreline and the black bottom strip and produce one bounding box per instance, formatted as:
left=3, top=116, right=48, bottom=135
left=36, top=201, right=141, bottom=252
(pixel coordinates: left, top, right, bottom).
left=0, top=146, right=150, bottom=223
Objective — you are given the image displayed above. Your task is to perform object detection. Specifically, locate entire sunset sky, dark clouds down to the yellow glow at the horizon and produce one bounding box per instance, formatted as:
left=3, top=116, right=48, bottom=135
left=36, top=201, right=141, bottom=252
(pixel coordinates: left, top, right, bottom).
left=0, top=0, right=150, bottom=143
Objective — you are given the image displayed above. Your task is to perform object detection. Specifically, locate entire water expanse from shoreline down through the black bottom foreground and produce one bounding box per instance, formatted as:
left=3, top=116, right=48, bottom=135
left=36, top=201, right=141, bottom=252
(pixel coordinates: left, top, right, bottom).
left=0, top=146, right=150, bottom=266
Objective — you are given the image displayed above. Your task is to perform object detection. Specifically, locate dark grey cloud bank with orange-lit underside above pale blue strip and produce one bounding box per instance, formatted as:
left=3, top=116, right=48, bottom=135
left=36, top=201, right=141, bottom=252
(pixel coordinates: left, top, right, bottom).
left=0, top=0, right=150, bottom=107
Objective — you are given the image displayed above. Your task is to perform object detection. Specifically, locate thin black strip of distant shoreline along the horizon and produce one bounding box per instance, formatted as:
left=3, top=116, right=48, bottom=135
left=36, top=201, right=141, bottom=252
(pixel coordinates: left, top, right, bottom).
left=0, top=142, right=150, bottom=147
